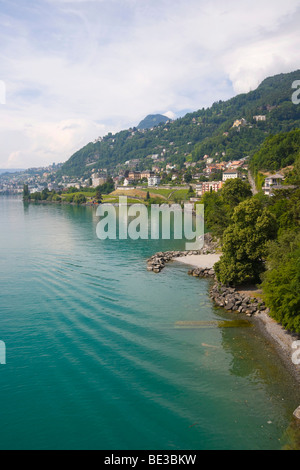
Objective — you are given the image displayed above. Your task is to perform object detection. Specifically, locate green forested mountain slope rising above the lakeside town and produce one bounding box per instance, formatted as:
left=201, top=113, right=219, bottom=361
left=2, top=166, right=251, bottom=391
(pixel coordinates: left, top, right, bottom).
left=61, top=70, right=300, bottom=177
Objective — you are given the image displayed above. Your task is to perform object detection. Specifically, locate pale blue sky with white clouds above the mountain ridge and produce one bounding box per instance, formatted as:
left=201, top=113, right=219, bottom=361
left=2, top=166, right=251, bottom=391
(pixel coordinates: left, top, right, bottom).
left=0, top=0, right=300, bottom=168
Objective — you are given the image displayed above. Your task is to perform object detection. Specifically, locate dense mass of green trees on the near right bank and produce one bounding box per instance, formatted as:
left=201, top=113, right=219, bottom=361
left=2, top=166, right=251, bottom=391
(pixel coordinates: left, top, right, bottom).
left=202, top=144, right=300, bottom=334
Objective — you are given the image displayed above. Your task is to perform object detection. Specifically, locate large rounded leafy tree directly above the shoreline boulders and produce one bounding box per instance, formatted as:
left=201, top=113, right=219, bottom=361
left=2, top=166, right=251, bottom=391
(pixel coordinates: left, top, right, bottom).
left=215, top=198, right=277, bottom=285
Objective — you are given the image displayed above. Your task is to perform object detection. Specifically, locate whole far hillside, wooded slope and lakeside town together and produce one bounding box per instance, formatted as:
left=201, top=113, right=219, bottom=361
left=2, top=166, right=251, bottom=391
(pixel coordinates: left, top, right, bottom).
left=0, top=71, right=300, bottom=201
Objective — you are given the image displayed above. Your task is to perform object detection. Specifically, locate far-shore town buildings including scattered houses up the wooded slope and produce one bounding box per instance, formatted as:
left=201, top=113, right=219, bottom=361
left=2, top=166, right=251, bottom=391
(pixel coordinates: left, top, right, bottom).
left=0, top=115, right=284, bottom=202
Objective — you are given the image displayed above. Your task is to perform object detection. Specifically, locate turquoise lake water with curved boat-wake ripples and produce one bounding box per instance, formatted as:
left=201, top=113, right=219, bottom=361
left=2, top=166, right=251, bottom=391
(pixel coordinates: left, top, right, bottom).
left=0, top=197, right=300, bottom=450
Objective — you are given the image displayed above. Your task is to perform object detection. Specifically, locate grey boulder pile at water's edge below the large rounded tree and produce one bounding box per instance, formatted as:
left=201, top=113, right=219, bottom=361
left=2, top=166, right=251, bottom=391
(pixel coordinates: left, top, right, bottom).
left=210, top=283, right=269, bottom=317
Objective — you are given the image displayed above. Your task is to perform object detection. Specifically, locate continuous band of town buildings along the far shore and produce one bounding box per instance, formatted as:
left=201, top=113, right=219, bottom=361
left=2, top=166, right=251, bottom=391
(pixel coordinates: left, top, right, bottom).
left=0, top=155, right=255, bottom=198
